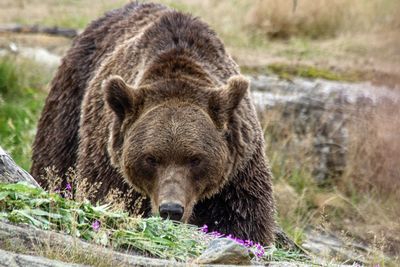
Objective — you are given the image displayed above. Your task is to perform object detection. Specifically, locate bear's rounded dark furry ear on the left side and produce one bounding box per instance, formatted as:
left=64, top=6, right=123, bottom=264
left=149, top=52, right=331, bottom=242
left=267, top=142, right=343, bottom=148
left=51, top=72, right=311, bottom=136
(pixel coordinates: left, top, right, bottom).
left=103, top=76, right=140, bottom=121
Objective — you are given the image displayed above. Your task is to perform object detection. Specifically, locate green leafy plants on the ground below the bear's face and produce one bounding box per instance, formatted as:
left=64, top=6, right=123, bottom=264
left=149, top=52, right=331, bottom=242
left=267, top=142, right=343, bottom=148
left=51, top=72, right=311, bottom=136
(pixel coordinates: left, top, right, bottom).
left=0, top=183, right=312, bottom=262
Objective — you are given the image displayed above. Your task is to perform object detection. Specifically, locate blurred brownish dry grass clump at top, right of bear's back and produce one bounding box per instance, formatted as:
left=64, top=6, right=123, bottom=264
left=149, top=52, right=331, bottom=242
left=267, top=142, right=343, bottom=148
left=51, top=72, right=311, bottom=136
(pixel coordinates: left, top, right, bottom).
left=247, top=0, right=351, bottom=38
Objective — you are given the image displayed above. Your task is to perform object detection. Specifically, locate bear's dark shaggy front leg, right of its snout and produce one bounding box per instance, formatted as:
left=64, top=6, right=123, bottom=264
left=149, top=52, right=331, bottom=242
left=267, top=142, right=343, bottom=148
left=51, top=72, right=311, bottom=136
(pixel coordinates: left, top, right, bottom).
left=191, top=151, right=275, bottom=245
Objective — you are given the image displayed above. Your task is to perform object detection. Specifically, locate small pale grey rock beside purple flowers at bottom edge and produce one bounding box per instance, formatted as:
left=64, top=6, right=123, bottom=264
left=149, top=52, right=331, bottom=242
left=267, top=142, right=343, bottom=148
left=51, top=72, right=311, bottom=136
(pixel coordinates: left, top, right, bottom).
left=195, top=238, right=251, bottom=265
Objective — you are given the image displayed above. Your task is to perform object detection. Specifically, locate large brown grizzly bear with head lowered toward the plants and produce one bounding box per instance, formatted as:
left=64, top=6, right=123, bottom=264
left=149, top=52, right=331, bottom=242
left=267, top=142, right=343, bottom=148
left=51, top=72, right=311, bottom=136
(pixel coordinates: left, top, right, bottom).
left=31, top=3, right=275, bottom=244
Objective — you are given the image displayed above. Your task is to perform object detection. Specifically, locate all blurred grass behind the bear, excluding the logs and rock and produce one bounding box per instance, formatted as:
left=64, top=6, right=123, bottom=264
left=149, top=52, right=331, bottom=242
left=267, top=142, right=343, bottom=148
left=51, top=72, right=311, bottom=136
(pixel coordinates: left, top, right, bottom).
left=0, top=0, right=400, bottom=266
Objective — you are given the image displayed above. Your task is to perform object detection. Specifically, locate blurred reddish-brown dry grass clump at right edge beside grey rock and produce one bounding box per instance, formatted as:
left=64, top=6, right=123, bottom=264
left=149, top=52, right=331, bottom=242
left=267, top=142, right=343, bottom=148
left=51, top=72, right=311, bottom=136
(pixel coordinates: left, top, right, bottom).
left=345, top=101, right=400, bottom=197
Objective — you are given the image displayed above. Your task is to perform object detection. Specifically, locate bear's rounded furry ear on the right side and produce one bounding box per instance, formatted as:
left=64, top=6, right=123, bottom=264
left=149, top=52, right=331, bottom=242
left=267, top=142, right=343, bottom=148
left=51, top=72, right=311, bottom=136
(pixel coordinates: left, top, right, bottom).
left=208, top=75, right=250, bottom=127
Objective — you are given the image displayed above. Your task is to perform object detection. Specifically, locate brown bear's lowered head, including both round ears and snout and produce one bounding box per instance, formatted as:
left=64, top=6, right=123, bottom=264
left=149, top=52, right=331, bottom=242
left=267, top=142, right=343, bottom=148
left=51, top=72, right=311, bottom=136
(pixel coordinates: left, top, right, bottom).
left=103, top=76, right=249, bottom=222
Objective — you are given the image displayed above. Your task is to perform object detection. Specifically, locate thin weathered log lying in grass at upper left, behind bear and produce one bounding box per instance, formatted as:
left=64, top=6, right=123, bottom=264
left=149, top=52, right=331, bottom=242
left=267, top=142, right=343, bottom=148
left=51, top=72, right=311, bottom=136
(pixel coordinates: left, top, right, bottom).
left=0, top=24, right=79, bottom=38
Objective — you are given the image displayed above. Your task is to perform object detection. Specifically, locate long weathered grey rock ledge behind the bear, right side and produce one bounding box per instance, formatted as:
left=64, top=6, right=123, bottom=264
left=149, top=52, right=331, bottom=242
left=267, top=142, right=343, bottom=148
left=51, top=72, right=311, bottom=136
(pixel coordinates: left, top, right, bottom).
left=249, top=75, right=400, bottom=183
